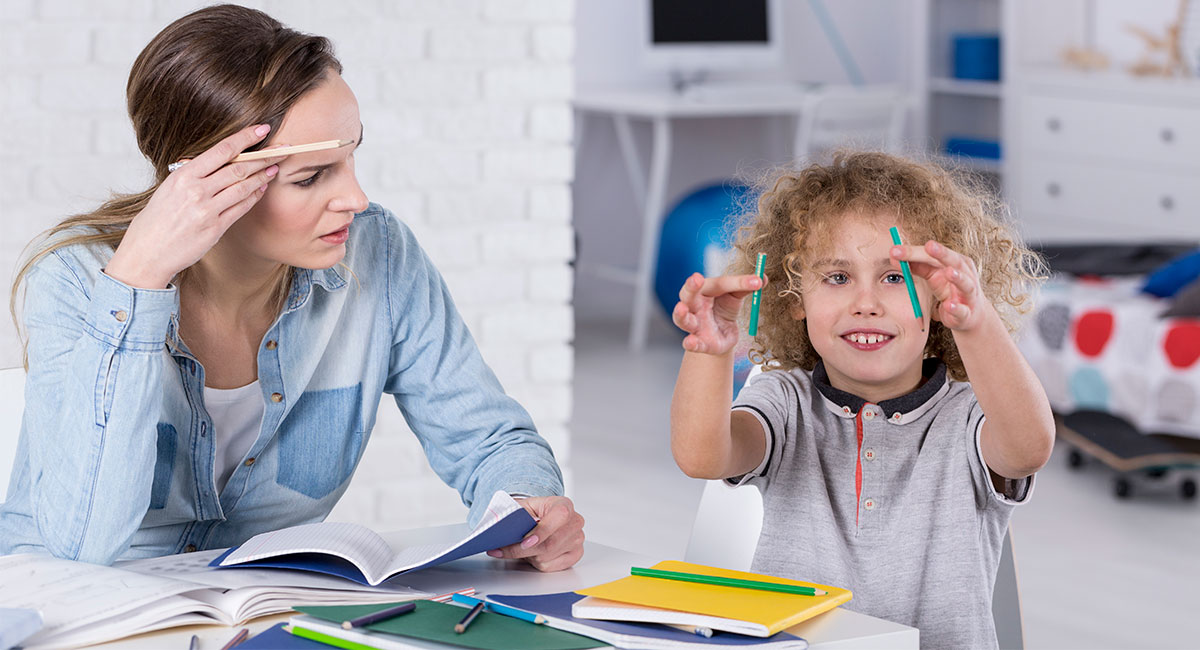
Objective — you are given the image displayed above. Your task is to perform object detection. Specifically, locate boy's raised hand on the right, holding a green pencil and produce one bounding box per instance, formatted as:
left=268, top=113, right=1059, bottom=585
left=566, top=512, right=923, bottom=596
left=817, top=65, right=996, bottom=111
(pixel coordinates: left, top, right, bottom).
left=892, top=240, right=991, bottom=331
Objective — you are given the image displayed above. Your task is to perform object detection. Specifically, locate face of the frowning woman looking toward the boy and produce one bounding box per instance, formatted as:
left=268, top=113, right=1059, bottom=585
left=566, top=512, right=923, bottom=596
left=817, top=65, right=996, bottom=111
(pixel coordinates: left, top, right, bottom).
left=222, top=71, right=367, bottom=269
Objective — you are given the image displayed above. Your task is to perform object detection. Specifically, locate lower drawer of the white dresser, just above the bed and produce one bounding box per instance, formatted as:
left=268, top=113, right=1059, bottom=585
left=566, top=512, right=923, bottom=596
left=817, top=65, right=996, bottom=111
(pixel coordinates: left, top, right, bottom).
left=1018, top=158, right=1200, bottom=231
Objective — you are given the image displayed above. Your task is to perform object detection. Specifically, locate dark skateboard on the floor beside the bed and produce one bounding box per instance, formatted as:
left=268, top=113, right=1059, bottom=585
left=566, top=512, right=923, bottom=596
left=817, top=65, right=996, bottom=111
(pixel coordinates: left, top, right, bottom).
left=1058, top=410, right=1200, bottom=501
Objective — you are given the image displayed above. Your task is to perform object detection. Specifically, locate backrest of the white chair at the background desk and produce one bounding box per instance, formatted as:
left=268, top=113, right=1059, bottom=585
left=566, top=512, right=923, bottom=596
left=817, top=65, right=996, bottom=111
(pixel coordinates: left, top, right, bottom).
left=793, top=85, right=910, bottom=163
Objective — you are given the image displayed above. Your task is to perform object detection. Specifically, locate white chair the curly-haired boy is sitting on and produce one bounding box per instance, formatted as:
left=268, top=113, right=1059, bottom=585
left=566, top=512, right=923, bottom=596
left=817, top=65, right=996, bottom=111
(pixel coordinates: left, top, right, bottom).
left=684, top=481, right=1025, bottom=650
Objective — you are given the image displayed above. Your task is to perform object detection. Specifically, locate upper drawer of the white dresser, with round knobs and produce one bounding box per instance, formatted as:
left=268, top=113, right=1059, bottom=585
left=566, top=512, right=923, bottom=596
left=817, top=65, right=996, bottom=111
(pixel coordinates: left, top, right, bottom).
left=1021, top=95, right=1200, bottom=169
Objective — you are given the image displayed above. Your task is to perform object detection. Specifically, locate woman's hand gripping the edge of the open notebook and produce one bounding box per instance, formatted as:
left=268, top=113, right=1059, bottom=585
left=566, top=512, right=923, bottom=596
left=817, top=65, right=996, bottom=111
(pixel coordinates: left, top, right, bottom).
left=487, top=496, right=583, bottom=571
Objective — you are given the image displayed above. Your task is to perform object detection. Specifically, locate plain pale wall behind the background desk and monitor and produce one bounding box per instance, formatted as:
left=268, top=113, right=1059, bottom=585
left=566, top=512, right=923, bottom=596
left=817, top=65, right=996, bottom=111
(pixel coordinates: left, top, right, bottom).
left=574, top=0, right=912, bottom=331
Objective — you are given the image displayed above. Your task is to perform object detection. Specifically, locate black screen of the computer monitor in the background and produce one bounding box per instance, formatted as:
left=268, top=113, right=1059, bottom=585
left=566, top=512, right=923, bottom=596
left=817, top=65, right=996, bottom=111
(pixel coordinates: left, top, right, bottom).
left=650, top=0, right=767, bottom=43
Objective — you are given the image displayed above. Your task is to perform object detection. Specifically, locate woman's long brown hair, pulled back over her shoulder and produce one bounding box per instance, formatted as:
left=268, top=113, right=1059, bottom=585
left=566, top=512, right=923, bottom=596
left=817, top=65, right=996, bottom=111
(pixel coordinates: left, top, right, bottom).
left=8, top=5, right=342, bottom=367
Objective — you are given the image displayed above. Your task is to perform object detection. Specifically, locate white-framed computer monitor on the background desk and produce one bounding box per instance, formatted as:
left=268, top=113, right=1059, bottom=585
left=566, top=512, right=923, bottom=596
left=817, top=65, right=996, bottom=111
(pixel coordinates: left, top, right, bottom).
left=642, top=0, right=784, bottom=80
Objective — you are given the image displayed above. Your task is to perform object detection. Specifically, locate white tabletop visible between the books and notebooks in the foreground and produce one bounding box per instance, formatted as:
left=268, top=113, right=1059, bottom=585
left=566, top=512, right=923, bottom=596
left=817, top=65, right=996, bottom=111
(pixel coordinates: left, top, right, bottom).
left=105, top=524, right=919, bottom=650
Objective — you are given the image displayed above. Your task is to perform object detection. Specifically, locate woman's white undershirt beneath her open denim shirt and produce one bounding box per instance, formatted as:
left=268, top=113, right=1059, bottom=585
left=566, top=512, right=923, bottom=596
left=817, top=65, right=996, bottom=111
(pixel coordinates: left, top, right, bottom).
left=204, top=379, right=266, bottom=492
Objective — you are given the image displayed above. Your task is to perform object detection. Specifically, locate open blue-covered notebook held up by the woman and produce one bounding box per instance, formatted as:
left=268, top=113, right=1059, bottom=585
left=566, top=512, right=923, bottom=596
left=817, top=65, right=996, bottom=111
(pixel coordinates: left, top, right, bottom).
left=212, top=492, right=536, bottom=585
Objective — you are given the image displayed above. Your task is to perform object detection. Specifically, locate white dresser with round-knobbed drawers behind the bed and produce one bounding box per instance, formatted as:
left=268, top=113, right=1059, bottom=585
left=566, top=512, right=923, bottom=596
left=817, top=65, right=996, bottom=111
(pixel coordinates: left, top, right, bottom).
left=1004, top=70, right=1200, bottom=241
